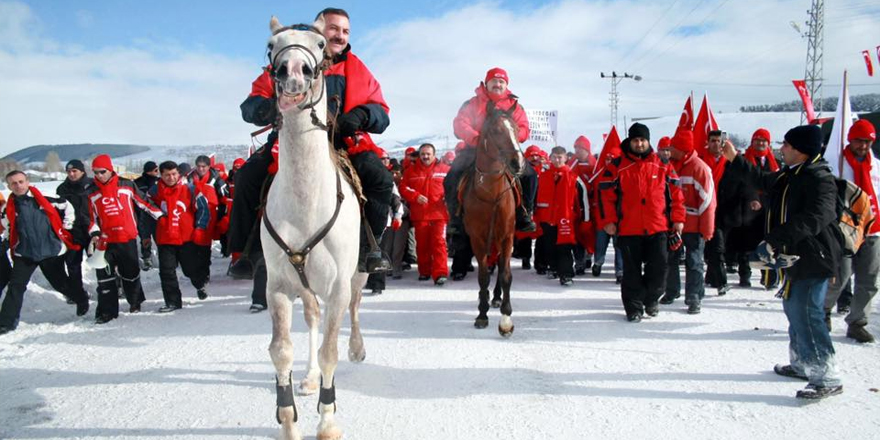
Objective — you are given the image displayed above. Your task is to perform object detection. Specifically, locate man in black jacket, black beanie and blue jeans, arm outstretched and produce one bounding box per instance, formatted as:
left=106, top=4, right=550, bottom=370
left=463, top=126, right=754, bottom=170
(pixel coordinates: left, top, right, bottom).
left=724, top=125, right=843, bottom=399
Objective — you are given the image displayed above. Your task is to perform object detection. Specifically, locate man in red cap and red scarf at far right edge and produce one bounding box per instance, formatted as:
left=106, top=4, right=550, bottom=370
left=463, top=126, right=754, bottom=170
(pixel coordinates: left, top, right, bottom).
left=825, top=119, right=880, bottom=343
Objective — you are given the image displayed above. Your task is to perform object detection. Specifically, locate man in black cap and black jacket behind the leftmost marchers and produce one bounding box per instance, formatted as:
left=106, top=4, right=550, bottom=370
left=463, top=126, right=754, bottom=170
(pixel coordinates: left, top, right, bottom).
left=55, top=159, right=92, bottom=303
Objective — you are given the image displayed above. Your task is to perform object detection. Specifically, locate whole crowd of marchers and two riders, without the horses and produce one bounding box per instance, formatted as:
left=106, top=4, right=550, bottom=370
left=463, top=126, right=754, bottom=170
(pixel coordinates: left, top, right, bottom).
left=0, top=8, right=880, bottom=398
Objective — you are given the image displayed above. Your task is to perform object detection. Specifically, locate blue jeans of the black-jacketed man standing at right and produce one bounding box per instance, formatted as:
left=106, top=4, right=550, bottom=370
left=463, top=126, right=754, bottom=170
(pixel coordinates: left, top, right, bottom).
left=782, top=278, right=840, bottom=387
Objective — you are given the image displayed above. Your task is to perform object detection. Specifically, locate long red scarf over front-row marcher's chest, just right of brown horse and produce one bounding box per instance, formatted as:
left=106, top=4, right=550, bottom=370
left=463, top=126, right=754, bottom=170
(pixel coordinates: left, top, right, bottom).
left=536, top=165, right=577, bottom=244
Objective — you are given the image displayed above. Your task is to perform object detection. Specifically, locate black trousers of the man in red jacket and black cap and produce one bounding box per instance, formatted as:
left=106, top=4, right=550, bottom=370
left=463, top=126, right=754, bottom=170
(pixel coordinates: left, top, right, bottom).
left=617, top=232, right=668, bottom=316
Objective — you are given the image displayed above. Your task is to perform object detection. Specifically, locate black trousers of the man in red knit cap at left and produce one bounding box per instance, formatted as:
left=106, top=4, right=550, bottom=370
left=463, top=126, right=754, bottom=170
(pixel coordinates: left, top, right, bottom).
left=95, top=239, right=146, bottom=318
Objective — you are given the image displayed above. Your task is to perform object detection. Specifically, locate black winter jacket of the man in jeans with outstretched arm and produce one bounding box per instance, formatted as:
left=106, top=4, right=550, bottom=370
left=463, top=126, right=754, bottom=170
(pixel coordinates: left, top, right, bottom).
left=725, top=156, right=841, bottom=280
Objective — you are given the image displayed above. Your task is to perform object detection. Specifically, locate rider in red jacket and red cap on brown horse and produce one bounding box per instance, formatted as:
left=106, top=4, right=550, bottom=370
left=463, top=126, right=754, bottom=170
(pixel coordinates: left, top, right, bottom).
left=444, top=67, right=537, bottom=236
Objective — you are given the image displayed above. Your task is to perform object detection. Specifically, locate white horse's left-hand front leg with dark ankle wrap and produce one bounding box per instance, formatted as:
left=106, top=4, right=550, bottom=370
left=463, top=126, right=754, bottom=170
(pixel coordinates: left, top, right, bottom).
left=268, top=285, right=302, bottom=440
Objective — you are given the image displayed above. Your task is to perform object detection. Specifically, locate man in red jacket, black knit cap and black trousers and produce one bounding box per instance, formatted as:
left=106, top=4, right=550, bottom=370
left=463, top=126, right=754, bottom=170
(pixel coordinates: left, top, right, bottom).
left=599, top=123, right=685, bottom=322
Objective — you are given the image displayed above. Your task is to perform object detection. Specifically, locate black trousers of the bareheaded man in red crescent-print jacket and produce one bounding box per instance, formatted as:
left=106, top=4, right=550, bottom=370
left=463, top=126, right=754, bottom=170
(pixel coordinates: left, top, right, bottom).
left=158, top=242, right=210, bottom=307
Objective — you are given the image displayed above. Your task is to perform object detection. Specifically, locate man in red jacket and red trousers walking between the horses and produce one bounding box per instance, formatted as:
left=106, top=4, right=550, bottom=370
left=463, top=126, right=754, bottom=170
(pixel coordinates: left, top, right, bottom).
left=400, top=144, right=449, bottom=286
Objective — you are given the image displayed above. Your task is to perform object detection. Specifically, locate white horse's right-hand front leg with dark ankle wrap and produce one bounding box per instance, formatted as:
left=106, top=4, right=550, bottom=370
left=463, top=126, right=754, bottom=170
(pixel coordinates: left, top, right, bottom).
left=317, top=279, right=351, bottom=440
